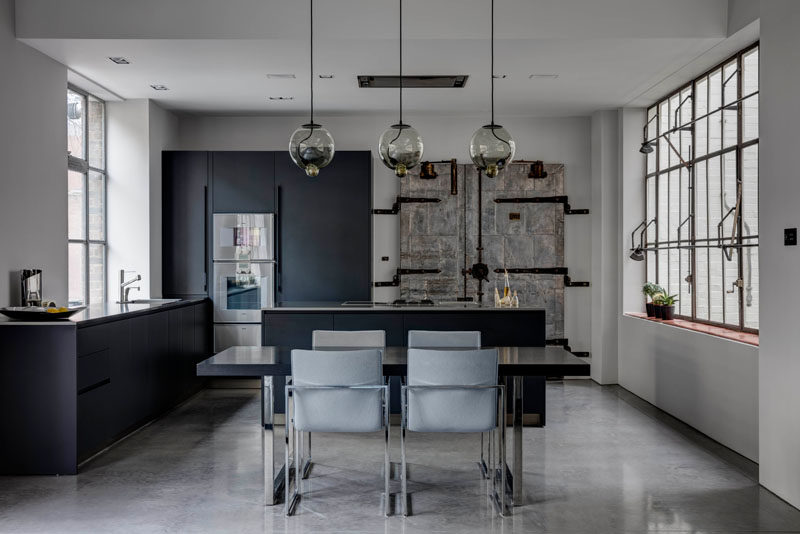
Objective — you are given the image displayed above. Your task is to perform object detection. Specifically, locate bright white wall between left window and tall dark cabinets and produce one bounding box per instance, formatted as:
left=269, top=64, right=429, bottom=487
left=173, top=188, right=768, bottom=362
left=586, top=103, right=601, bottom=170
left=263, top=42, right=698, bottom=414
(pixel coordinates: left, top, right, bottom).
left=106, top=100, right=178, bottom=300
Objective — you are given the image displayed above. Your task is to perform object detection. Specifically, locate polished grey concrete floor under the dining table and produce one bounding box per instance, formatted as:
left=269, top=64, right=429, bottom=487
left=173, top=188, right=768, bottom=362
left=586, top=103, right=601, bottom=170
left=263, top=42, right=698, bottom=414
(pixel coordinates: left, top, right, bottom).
left=0, top=381, right=800, bottom=534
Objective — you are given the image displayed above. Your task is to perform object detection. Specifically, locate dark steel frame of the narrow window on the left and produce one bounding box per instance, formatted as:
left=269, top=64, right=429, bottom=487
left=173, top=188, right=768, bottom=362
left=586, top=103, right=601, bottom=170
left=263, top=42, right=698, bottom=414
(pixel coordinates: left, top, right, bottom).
left=67, top=84, right=108, bottom=305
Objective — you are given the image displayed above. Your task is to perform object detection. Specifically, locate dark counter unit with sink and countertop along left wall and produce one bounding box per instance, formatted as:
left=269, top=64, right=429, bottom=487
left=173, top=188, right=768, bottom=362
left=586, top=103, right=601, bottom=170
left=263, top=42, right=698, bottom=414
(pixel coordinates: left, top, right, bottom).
left=0, top=299, right=212, bottom=475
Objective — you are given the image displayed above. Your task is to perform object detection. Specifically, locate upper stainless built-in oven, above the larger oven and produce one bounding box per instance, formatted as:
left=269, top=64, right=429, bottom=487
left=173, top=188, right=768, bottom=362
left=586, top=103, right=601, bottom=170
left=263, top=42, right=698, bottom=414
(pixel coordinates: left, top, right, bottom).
left=213, top=213, right=275, bottom=261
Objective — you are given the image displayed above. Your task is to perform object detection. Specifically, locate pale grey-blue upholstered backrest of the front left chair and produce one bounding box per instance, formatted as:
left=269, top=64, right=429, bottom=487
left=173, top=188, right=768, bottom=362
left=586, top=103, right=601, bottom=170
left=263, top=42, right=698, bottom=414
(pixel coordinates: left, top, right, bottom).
left=292, top=349, right=388, bottom=432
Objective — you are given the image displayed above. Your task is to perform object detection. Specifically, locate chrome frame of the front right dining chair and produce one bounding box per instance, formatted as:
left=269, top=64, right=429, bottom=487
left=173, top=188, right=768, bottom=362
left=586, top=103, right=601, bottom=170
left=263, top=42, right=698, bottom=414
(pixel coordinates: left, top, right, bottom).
left=400, top=384, right=511, bottom=517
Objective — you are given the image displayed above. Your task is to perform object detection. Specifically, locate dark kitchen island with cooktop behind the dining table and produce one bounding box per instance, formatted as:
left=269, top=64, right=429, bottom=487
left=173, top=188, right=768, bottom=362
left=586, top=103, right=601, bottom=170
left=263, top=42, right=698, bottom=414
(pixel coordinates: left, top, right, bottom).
left=262, top=302, right=547, bottom=418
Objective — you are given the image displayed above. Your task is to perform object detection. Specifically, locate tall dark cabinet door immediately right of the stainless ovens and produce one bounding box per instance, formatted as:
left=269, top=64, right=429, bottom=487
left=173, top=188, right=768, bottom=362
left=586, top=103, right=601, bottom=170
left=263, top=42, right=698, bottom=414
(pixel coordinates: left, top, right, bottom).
left=275, top=151, right=372, bottom=302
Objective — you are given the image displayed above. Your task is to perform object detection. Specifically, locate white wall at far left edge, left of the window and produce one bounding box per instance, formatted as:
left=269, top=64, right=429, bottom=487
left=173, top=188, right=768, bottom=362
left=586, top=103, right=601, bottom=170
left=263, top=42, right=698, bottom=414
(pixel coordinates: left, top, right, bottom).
left=0, top=0, right=67, bottom=306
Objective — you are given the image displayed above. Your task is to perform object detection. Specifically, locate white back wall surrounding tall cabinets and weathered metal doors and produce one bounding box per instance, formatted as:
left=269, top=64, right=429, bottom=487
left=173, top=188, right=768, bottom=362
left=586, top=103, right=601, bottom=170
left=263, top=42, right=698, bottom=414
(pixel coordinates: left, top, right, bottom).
left=176, top=115, right=593, bottom=350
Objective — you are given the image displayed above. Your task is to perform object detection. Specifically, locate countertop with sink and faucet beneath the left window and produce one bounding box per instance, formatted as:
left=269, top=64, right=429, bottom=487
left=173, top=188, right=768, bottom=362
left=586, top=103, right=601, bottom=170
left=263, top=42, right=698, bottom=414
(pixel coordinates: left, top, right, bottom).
left=0, top=297, right=205, bottom=328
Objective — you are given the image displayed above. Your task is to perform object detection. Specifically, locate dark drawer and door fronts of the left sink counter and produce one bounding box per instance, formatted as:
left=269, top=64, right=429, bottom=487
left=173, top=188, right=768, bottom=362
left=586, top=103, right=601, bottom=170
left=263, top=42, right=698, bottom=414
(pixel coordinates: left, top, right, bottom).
left=77, top=301, right=212, bottom=461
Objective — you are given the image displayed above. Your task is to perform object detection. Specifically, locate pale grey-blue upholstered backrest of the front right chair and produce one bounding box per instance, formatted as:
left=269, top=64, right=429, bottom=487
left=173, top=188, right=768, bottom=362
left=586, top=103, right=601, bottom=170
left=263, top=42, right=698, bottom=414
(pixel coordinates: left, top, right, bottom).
left=407, top=349, right=497, bottom=432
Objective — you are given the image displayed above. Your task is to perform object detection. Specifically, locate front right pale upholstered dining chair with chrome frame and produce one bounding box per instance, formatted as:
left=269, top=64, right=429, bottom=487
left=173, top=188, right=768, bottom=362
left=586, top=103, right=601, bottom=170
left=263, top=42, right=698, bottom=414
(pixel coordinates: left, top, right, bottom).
left=400, top=348, right=506, bottom=515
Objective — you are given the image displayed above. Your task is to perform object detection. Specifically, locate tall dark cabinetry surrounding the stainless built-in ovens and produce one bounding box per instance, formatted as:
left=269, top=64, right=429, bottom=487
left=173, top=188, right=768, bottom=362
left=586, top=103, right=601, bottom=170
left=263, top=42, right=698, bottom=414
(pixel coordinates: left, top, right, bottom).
left=162, top=151, right=372, bottom=302
